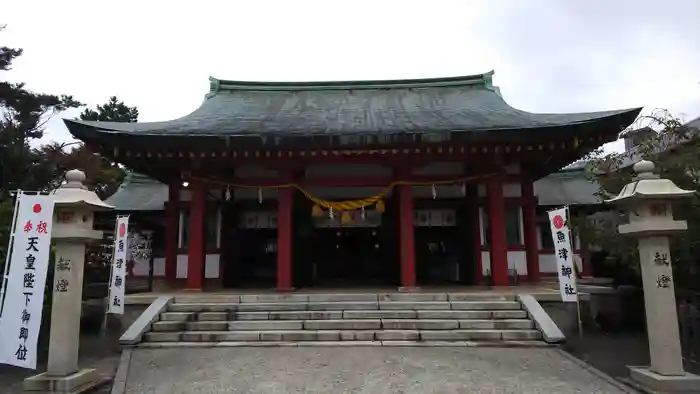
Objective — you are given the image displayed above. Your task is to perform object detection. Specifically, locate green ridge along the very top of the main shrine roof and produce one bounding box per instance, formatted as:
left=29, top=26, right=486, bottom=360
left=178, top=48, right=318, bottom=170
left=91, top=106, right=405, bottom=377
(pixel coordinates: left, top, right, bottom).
left=209, top=70, right=494, bottom=93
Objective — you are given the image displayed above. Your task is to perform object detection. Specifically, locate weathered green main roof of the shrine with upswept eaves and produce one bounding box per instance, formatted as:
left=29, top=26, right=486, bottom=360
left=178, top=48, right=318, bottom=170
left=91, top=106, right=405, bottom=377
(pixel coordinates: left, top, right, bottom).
left=65, top=72, right=640, bottom=139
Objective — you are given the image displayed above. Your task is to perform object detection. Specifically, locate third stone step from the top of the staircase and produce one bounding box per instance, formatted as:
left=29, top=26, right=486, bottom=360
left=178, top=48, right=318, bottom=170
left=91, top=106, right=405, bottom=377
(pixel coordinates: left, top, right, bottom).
left=160, top=310, right=527, bottom=322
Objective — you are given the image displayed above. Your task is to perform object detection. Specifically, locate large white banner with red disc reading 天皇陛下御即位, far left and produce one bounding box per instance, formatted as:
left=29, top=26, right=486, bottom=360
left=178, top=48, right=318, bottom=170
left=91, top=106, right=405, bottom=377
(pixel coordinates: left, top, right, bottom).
left=0, top=193, right=54, bottom=369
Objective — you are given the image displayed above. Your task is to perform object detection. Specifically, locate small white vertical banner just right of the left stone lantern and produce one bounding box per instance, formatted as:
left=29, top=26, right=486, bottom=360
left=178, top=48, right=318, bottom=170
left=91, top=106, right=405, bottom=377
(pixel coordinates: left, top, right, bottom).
left=107, top=216, right=129, bottom=315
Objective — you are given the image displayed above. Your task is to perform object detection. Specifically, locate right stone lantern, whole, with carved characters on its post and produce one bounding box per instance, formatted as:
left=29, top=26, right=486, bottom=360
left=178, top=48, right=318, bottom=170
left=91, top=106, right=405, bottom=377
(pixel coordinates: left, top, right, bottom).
left=607, top=160, right=700, bottom=393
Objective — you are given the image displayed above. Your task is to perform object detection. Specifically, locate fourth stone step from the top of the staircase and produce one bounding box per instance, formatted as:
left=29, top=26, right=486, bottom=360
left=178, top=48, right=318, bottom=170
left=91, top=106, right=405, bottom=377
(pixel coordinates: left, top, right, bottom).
left=152, top=319, right=534, bottom=332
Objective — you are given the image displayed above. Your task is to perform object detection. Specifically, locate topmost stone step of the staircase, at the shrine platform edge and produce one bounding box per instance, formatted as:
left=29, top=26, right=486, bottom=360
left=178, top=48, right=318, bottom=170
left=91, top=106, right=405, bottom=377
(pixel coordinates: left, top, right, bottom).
left=175, top=293, right=515, bottom=304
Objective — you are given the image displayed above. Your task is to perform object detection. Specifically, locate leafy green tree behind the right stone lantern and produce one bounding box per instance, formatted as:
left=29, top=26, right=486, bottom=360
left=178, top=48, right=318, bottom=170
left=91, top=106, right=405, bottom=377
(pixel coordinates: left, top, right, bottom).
left=587, top=110, right=700, bottom=288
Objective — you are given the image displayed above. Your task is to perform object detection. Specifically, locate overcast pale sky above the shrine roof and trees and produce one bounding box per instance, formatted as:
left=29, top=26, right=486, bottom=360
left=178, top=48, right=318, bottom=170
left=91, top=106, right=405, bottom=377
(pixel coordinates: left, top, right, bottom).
left=0, top=0, right=700, bottom=150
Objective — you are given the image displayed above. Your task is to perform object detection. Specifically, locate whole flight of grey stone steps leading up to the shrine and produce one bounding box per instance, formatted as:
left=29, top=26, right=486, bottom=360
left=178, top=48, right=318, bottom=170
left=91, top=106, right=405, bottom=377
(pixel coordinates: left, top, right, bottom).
left=140, top=293, right=546, bottom=347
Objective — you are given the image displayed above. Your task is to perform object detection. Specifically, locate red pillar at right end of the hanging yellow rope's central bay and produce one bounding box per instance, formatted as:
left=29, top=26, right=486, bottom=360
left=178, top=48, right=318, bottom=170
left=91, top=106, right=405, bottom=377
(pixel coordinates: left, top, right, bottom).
left=398, top=185, right=416, bottom=288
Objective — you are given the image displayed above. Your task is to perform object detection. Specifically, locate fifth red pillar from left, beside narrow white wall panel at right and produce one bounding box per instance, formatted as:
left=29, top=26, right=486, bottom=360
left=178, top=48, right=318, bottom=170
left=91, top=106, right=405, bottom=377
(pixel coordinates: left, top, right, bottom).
left=487, top=176, right=508, bottom=286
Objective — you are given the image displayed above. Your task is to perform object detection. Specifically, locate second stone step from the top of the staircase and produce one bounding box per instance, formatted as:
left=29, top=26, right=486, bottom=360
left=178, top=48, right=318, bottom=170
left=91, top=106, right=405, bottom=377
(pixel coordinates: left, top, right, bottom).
left=168, top=301, right=520, bottom=312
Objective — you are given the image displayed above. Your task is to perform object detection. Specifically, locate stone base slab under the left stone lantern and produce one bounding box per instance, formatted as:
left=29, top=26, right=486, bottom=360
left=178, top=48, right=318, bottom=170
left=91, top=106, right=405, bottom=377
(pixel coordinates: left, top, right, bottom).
left=24, top=369, right=104, bottom=394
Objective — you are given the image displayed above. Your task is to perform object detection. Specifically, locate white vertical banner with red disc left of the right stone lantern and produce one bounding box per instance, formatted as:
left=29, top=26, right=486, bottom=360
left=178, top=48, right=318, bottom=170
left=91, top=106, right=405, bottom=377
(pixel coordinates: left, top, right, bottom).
left=548, top=207, right=578, bottom=302
